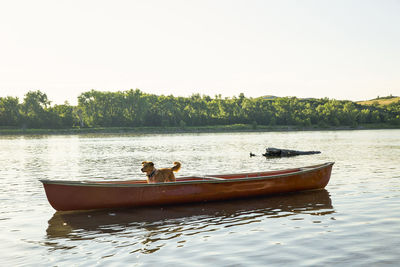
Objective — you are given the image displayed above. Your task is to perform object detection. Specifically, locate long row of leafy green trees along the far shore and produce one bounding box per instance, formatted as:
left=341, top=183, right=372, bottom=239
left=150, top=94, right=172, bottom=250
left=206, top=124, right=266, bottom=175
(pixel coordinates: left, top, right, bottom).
left=0, top=89, right=400, bottom=128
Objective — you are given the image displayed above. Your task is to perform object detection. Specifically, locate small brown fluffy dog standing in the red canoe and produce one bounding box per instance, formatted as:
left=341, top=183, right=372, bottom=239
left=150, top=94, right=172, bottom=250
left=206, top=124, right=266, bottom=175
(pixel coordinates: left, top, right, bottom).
left=141, top=161, right=181, bottom=184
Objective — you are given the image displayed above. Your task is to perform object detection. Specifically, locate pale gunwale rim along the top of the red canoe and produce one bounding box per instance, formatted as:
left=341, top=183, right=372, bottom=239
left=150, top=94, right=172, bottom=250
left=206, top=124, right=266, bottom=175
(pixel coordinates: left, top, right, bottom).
left=39, top=162, right=334, bottom=187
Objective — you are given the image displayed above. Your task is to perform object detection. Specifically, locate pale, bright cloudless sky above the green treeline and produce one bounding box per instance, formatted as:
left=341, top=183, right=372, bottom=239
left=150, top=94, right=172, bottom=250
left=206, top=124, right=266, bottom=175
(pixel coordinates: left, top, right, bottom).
left=0, top=0, right=400, bottom=104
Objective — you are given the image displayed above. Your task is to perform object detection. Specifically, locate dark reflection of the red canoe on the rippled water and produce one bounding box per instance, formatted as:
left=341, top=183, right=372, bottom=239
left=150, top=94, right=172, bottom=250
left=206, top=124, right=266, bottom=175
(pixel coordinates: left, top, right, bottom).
left=47, top=189, right=334, bottom=240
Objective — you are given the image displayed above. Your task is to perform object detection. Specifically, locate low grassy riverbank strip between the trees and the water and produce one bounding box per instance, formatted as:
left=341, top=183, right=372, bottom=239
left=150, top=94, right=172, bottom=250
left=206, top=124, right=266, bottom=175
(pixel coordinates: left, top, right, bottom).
left=0, top=124, right=400, bottom=135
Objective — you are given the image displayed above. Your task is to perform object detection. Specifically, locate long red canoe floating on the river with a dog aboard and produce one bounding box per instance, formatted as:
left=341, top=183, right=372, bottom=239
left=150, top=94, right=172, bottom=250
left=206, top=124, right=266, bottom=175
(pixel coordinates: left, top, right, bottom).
left=40, top=162, right=334, bottom=211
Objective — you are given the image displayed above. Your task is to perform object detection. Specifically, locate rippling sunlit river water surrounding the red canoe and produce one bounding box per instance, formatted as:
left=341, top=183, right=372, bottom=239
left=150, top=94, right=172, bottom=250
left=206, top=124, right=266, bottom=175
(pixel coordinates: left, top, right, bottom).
left=0, top=130, right=400, bottom=266
